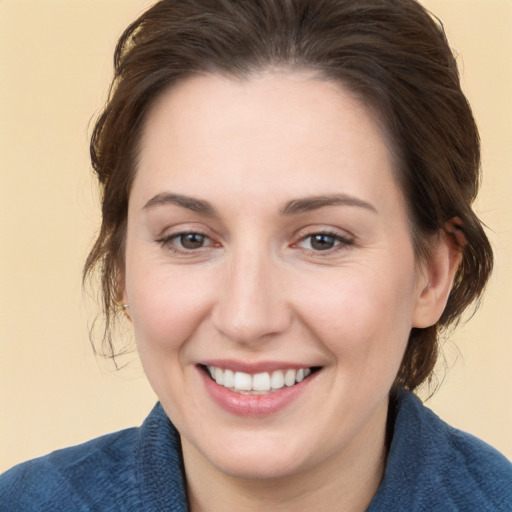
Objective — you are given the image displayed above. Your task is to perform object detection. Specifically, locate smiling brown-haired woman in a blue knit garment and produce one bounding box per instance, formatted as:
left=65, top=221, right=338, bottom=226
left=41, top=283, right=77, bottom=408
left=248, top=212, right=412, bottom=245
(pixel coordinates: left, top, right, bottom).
left=0, top=0, right=512, bottom=511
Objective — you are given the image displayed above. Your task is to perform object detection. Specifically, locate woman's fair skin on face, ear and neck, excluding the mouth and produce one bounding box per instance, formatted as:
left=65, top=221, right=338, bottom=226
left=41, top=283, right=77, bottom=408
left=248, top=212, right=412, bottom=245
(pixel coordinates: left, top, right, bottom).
left=123, top=71, right=458, bottom=511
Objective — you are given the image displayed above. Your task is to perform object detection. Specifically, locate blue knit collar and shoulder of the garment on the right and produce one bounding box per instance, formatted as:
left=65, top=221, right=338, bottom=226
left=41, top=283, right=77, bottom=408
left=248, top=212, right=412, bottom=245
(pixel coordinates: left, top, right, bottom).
left=375, top=392, right=512, bottom=512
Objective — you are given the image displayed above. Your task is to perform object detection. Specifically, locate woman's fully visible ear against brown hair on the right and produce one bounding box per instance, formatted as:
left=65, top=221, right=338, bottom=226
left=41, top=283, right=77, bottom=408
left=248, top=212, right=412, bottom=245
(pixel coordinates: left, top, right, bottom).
left=412, top=217, right=466, bottom=328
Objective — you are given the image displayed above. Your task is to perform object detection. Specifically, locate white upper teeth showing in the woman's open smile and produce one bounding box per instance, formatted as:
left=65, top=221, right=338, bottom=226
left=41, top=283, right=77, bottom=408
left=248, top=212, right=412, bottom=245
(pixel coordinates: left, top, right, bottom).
left=203, top=365, right=320, bottom=395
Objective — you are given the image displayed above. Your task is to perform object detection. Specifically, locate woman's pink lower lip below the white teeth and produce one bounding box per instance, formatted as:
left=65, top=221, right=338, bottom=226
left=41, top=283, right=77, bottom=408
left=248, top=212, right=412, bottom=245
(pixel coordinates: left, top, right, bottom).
left=199, top=369, right=316, bottom=418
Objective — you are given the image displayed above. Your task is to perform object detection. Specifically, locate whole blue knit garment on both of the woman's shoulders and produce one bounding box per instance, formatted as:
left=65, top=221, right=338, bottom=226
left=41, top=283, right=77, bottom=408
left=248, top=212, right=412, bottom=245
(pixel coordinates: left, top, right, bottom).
left=0, top=392, right=512, bottom=512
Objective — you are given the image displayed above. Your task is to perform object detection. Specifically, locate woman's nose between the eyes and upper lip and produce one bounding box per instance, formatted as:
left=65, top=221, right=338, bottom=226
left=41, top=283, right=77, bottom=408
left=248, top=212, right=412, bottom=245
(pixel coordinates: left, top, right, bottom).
left=212, top=247, right=292, bottom=346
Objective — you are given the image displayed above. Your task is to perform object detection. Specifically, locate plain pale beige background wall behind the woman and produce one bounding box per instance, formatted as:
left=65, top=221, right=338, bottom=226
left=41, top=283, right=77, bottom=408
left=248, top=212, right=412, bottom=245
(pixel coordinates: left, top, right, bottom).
left=0, top=0, right=512, bottom=471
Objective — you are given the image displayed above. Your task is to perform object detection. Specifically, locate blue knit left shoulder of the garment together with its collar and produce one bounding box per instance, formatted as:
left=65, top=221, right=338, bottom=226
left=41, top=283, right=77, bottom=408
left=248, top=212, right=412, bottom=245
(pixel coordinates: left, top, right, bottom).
left=0, top=403, right=187, bottom=512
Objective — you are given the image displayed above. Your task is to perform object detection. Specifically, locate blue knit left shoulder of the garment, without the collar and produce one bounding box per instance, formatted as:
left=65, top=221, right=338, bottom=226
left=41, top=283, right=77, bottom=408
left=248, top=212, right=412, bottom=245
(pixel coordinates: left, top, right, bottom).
left=0, top=428, right=138, bottom=512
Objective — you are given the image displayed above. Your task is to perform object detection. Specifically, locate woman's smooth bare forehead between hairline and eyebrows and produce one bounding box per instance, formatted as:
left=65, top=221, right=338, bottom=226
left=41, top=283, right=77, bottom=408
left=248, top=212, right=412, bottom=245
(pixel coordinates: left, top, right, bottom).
left=134, top=71, right=400, bottom=212
